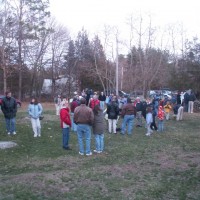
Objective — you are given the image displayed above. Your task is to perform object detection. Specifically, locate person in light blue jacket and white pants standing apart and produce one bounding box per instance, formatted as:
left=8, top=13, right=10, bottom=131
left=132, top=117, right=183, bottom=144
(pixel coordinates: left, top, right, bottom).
left=28, top=98, right=43, bottom=137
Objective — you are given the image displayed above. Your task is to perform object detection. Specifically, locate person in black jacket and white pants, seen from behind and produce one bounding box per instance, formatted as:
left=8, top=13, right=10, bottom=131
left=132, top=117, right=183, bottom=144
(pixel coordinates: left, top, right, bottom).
left=106, top=97, right=119, bottom=134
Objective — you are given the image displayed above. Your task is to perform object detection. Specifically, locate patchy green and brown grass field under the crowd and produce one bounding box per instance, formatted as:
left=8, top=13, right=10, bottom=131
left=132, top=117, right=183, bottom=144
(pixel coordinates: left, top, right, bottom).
left=0, top=105, right=200, bottom=200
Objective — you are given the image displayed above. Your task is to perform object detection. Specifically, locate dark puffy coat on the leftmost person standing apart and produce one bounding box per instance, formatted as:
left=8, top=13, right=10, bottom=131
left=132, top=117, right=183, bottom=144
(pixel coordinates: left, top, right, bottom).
left=1, top=97, right=17, bottom=119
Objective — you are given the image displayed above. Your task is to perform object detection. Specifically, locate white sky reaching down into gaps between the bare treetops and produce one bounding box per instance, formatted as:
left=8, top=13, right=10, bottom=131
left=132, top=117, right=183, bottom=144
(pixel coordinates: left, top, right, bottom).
left=50, top=0, right=200, bottom=57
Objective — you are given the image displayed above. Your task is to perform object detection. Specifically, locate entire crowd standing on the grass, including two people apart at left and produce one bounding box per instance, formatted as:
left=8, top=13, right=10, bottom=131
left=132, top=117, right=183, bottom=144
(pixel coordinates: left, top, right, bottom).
left=1, top=90, right=196, bottom=156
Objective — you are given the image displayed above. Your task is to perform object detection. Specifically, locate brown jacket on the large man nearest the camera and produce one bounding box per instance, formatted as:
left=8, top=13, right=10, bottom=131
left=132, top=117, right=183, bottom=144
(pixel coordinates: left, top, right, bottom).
left=74, top=104, right=94, bottom=125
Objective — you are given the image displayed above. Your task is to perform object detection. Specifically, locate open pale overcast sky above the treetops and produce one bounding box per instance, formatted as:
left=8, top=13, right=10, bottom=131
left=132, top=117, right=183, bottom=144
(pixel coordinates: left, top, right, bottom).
left=50, top=0, right=200, bottom=35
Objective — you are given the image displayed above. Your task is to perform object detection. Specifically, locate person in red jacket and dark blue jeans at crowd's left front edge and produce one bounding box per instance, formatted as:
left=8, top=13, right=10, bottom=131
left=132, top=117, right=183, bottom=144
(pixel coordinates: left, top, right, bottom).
left=60, top=102, right=71, bottom=150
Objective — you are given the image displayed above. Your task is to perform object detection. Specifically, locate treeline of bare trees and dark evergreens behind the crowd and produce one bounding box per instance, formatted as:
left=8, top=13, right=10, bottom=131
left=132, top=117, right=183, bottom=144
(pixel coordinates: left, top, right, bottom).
left=0, top=0, right=200, bottom=99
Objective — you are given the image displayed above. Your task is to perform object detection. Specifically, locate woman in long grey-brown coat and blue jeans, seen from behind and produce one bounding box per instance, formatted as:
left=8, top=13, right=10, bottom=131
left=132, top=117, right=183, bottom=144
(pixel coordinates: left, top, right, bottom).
left=93, top=105, right=105, bottom=153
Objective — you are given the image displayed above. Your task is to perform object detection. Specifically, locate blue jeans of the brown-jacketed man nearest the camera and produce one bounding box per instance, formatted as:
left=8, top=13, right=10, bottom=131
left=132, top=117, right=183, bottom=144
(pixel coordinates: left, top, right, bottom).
left=77, top=124, right=91, bottom=154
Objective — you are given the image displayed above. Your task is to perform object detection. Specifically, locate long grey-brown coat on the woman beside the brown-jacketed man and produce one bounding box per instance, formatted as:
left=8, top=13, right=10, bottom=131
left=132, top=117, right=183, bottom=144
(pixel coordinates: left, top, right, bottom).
left=93, top=111, right=105, bottom=134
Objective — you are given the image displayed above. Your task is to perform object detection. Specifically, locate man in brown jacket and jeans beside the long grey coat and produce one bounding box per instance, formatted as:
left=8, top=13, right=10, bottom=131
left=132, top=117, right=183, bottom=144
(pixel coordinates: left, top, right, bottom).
left=74, top=98, right=94, bottom=156
